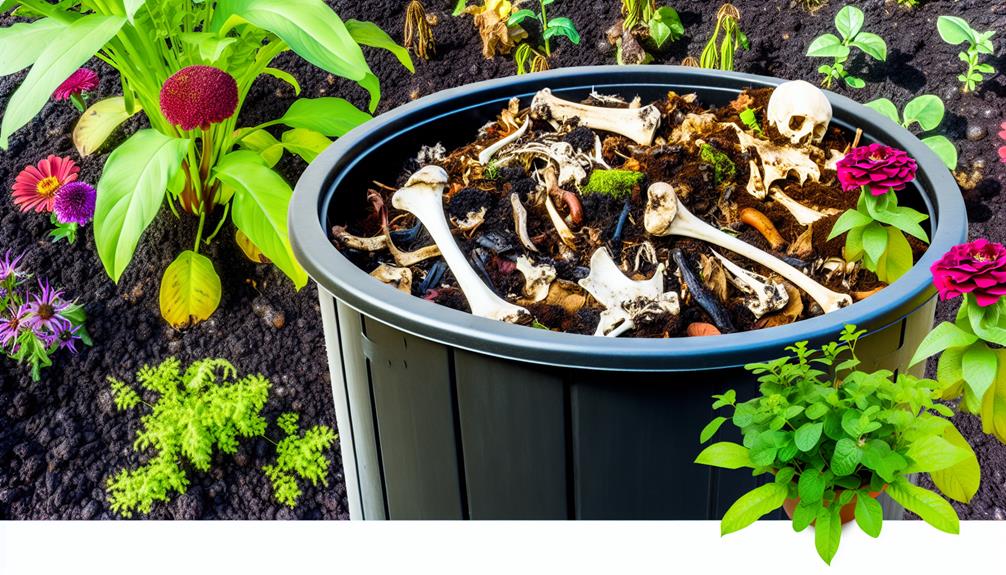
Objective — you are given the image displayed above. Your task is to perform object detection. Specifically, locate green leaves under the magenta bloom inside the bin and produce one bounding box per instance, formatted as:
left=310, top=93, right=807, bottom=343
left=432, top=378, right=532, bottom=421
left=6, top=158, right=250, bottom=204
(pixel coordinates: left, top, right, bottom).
left=828, top=190, right=930, bottom=283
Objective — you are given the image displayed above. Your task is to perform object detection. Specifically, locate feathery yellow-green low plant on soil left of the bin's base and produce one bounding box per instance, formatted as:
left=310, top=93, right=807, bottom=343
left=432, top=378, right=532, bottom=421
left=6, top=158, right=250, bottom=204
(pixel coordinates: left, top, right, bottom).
left=108, top=358, right=336, bottom=517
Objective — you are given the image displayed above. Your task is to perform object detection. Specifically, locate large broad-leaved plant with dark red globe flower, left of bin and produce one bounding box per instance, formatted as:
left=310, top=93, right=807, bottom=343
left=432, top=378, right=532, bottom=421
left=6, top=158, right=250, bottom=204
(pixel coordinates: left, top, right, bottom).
left=0, top=0, right=412, bottom=327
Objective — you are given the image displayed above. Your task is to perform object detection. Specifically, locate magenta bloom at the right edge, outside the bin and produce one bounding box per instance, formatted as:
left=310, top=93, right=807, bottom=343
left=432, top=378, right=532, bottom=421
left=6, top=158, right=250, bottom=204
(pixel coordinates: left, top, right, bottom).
left=931, top=239, right=1006, bottom=308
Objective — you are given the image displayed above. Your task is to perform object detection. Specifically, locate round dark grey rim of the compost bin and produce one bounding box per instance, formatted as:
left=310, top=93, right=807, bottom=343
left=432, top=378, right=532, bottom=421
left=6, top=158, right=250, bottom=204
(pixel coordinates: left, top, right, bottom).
left=289, top=65, right=967, bottom=371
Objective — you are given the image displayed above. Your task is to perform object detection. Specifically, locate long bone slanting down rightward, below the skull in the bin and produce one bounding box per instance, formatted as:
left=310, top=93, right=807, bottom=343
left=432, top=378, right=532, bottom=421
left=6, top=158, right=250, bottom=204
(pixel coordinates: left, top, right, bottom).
left=643, top=182, right=852, bottom=312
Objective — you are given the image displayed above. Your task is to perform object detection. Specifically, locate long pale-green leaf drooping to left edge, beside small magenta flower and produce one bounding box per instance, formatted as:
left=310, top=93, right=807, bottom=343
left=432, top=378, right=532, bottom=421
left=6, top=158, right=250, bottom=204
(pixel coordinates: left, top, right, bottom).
left=0, top=14, right=126, bottom=150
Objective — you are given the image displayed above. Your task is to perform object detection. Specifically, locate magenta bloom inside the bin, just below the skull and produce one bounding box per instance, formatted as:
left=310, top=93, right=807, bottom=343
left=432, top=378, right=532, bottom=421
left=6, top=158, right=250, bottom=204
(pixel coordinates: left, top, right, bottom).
left=838, top=144, right=917, bottom=196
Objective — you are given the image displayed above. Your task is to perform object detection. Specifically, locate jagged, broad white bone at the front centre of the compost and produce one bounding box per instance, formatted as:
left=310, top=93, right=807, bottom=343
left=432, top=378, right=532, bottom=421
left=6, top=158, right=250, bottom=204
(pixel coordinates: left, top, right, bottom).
left=579, top=247, right=681, bottom=338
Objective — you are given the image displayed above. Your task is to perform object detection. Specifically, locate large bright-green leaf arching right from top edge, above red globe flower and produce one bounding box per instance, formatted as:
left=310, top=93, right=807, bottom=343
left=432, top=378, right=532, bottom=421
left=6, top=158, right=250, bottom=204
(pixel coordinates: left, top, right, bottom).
left=209, top=0, right=380, bottom=111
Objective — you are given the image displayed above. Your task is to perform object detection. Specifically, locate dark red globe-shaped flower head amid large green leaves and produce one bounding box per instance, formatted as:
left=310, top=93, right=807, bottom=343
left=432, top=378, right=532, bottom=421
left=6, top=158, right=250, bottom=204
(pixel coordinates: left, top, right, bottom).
left=161, top=66, right=237, bottom=130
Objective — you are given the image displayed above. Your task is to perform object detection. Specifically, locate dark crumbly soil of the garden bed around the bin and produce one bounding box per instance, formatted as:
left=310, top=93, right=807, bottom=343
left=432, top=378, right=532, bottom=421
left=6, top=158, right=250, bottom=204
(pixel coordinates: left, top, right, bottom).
left=0, top=0, right=1006, bottom=519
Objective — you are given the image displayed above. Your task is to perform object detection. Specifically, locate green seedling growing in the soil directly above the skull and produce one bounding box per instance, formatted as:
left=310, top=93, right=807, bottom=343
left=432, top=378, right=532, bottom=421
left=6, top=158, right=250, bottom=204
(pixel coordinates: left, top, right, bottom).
left=807, top=6, right=887, bottom=88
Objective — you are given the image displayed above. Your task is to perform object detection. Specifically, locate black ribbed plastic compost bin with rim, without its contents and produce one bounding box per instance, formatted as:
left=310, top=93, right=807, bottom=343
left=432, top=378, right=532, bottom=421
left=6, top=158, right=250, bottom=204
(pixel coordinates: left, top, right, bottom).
left=290, top=66, right=967, bottom=519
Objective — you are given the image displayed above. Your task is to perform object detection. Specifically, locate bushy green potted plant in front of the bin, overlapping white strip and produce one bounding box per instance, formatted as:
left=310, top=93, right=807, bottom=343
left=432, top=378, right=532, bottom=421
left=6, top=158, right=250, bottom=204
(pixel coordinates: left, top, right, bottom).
left=695, top=326, right=980, bottom=563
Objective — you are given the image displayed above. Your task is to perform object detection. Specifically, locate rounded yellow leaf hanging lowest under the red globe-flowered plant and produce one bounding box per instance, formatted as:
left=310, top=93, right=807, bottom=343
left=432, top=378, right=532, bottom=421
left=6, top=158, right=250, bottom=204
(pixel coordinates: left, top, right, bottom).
left=160, top=250, right=220, bottom=329
